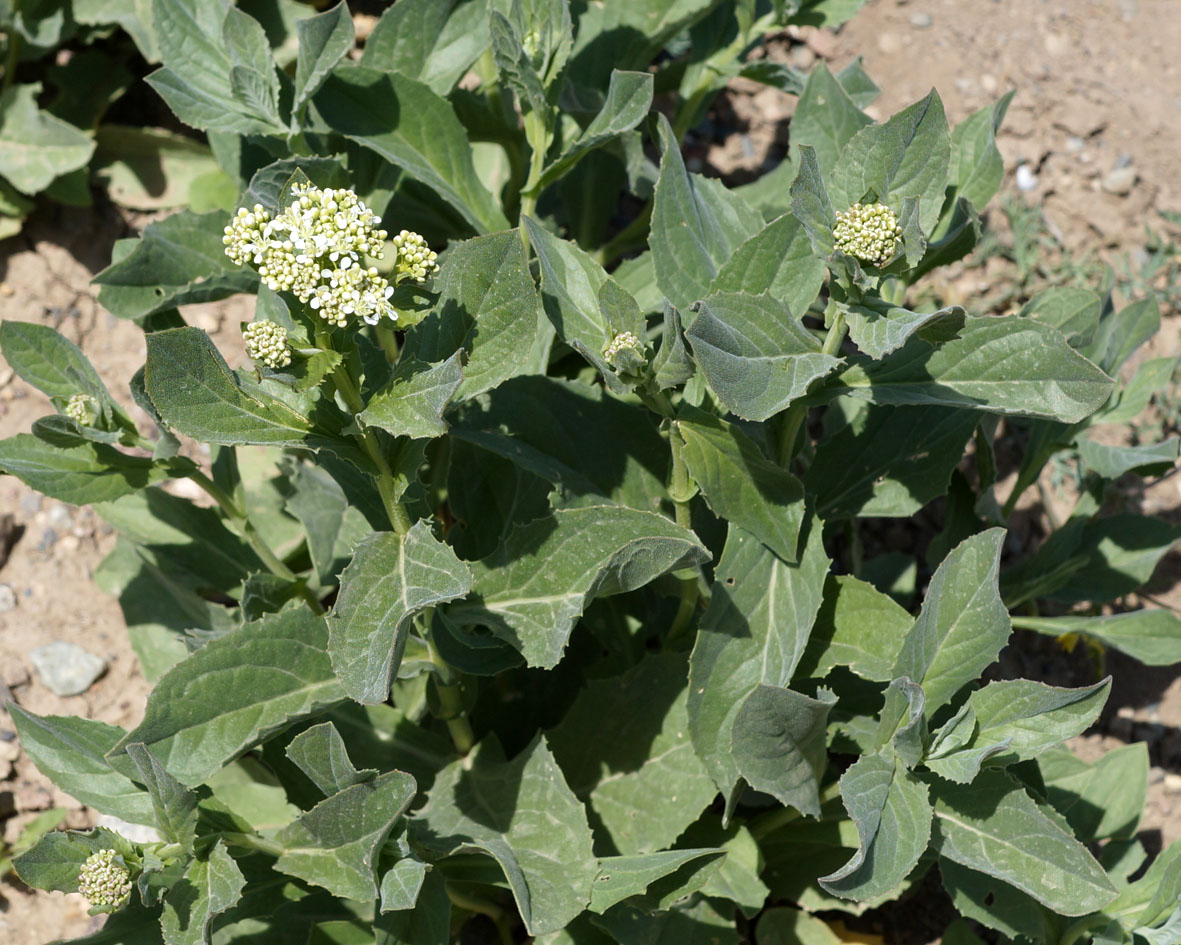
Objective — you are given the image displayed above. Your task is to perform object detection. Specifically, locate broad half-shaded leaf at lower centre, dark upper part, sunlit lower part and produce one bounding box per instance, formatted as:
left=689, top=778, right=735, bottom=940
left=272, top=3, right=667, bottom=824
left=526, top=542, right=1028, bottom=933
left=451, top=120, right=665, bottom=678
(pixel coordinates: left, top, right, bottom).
left=548, top=653, right=717, bottom=859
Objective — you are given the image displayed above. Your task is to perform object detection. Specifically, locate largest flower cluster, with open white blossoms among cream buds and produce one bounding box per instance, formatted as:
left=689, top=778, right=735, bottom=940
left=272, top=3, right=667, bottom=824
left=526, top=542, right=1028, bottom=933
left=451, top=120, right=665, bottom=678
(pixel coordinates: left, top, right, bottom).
left=222, top=184, right=438, bottom=327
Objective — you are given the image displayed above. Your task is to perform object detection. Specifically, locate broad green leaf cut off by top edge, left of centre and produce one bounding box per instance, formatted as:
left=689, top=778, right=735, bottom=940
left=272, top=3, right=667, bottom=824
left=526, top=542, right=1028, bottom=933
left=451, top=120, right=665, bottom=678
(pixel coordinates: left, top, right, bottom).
left=361, top=0, right=491, bottom=96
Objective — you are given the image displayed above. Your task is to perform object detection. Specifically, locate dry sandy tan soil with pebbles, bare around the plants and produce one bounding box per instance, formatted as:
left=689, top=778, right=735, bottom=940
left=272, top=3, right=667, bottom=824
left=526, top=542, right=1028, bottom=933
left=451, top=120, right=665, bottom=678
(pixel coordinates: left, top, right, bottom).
left=0, top=0, right=1181, bottom=945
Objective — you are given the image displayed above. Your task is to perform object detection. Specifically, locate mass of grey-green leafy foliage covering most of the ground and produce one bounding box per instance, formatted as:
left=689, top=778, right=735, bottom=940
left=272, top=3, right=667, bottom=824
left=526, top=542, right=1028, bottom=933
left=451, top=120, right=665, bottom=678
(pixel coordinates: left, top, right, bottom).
left=0, top=0, right=1181, bottom=945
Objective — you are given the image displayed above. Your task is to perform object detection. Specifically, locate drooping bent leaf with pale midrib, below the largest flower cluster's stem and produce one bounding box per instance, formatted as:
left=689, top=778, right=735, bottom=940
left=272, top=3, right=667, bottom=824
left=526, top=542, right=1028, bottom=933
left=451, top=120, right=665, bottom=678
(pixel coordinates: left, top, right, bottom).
left=328, top=521, right=472, bottom=704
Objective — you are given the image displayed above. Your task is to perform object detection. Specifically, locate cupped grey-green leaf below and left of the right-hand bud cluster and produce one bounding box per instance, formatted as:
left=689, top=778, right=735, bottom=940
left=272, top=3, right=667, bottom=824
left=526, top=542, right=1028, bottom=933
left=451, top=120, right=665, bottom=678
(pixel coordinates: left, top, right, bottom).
left=685, top=293, right=840, bottom=421
